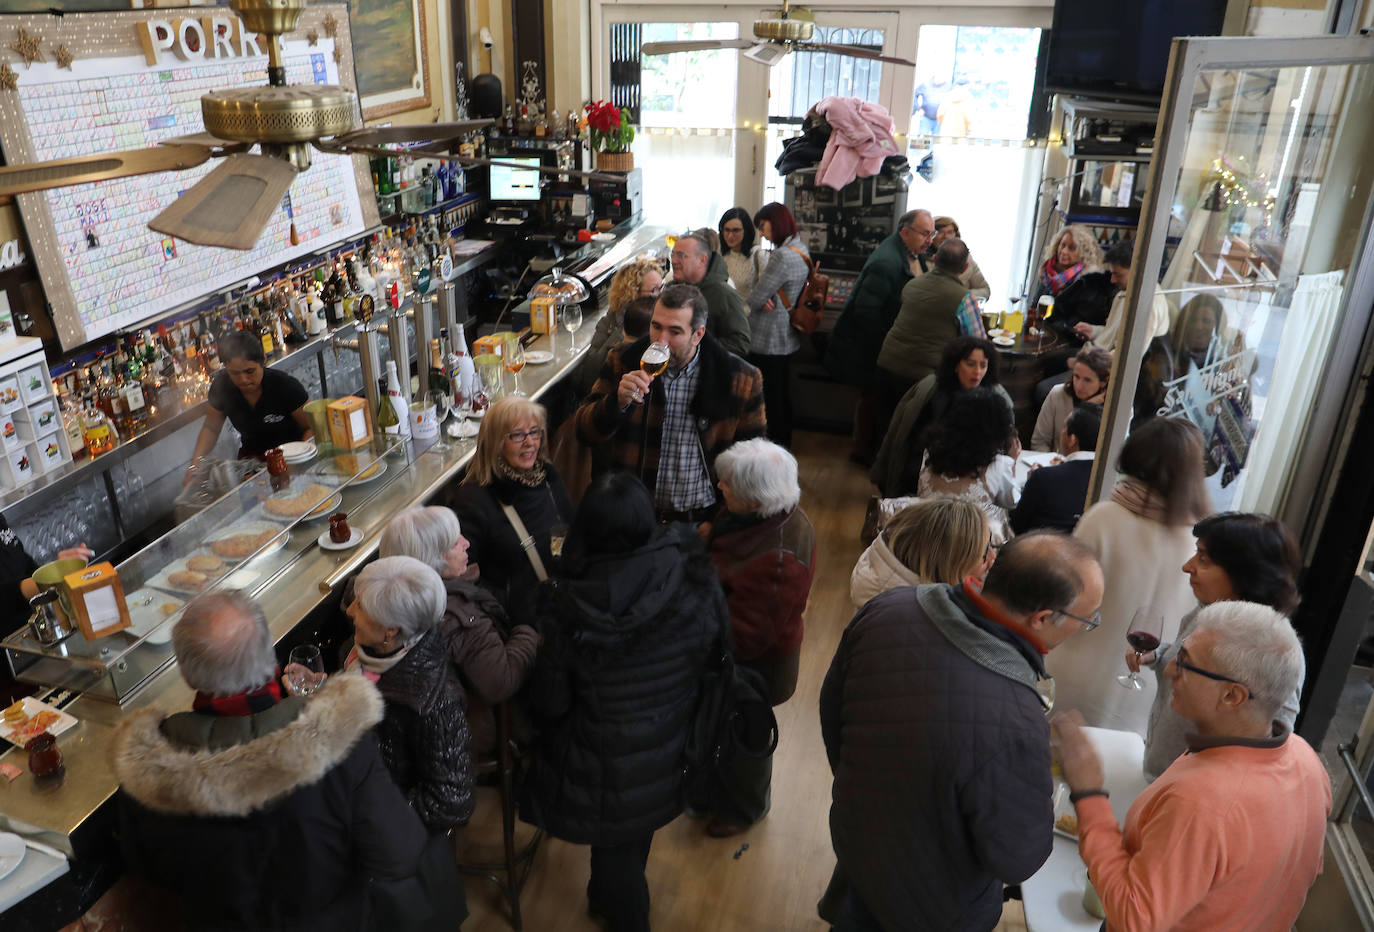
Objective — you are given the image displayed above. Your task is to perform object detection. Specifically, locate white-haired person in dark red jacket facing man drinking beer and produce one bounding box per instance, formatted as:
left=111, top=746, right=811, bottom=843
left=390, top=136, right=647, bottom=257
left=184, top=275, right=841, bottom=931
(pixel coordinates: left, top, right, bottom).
left=706, top=437, right=816, bottom=839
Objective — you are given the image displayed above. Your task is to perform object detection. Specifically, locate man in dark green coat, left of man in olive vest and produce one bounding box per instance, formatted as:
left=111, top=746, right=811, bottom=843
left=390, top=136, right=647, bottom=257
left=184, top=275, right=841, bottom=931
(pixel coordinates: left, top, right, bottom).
left=826, top=210, right=936, bottom=465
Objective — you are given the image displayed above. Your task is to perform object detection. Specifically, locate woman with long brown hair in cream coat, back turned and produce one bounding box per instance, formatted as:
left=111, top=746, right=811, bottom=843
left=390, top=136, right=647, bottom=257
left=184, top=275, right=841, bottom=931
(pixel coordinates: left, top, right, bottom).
left=1046, top=418, right=1212, bottom=737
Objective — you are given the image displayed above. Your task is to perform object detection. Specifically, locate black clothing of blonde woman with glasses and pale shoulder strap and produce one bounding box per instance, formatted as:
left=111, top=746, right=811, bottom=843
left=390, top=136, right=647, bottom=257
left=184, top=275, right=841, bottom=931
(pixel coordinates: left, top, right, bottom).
left=453, top=464, right=573, bottom=624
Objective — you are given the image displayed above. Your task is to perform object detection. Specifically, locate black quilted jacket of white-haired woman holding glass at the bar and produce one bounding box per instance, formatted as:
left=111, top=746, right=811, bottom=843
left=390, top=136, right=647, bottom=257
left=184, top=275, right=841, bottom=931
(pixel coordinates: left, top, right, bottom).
left=376, top=625, right=473, bottom=832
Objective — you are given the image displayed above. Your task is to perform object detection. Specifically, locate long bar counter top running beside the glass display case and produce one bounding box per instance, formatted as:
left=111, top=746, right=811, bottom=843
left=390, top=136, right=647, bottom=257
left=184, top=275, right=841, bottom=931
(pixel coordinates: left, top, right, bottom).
left=0, top=227, right=664, bottom=856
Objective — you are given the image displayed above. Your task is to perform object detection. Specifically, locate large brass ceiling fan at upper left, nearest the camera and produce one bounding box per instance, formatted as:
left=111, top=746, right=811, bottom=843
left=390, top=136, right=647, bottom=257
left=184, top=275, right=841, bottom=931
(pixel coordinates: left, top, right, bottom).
left=0, top=0, right=613, bottom=249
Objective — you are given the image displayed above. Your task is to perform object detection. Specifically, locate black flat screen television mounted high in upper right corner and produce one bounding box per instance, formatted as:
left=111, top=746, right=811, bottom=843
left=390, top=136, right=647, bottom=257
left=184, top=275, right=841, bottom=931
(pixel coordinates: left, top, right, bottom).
left=1044, top=0, right=1227, bottom=100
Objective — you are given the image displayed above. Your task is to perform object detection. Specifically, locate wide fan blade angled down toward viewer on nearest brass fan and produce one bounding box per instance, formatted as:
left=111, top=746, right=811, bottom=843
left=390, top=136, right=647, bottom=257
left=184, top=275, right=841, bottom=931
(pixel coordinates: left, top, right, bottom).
left=148, top=154, right=295, bottom=249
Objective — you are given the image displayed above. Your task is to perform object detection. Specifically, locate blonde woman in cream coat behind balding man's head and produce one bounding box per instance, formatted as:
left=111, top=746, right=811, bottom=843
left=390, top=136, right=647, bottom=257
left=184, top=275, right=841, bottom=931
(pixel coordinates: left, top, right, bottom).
left=849, top=498, right=996, bottom=608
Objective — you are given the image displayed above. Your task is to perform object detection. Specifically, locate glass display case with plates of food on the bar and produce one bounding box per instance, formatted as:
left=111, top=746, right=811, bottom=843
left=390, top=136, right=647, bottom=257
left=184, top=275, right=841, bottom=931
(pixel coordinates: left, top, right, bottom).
left=0, top=439, right=415, bottom=704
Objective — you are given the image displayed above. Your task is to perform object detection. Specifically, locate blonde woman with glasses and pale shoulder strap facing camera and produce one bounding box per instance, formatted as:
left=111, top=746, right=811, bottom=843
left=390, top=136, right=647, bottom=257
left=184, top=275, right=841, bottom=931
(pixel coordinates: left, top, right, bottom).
left=453, top=396, right=573, bottom=623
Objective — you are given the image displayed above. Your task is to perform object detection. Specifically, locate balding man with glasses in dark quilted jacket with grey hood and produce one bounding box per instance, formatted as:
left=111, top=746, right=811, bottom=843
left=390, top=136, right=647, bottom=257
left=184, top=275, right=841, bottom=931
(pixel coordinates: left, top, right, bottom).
left=820, top=532, right=1102, bottom=932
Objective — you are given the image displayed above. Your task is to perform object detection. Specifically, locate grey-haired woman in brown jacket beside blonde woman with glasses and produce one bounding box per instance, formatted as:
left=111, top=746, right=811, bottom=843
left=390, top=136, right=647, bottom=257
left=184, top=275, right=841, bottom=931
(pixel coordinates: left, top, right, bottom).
left=378, top=506, right=539, bottom=756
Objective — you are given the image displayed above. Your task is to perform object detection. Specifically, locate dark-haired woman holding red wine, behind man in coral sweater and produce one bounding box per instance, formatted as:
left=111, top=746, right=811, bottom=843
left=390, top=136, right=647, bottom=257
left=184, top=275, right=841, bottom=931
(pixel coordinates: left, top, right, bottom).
left=1125, top=511, right=1303, bottom=779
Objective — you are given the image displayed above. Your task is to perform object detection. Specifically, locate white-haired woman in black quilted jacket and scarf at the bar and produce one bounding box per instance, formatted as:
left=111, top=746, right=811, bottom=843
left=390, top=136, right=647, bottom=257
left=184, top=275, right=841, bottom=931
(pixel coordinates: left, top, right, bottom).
left=348, top=557, right=473, bottom=834
